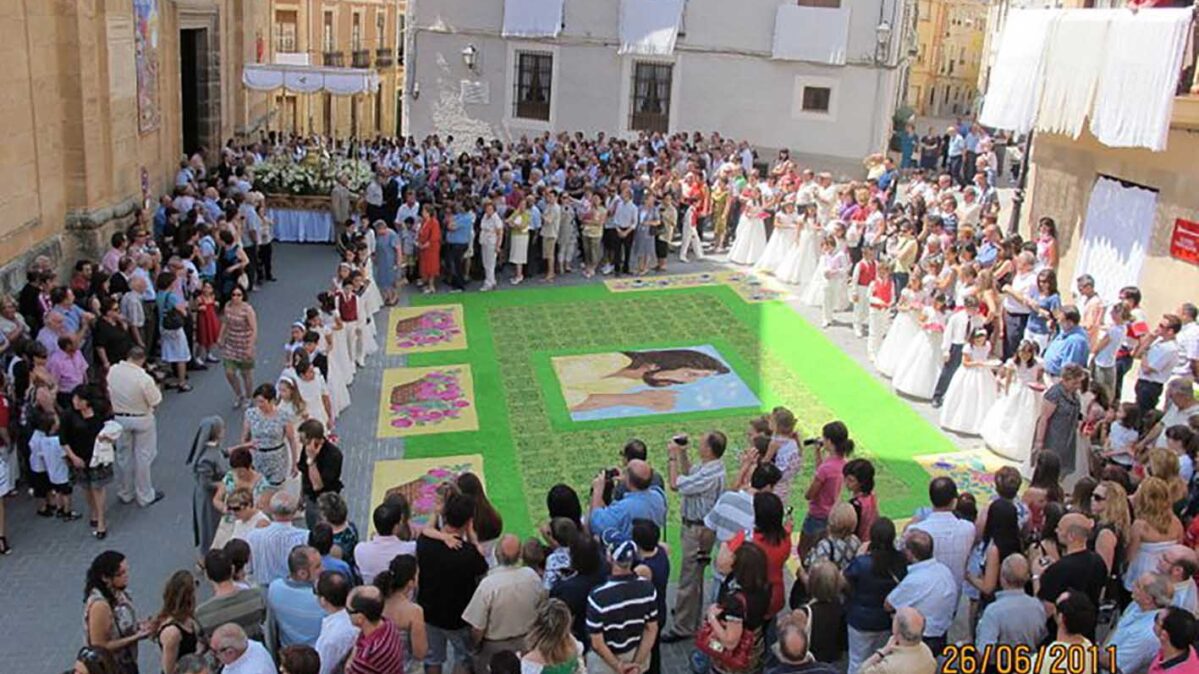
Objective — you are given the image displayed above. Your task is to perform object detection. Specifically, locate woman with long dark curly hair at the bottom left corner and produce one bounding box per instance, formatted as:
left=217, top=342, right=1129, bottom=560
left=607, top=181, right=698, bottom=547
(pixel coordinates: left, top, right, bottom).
left=83, top=550, right=153, bottom=674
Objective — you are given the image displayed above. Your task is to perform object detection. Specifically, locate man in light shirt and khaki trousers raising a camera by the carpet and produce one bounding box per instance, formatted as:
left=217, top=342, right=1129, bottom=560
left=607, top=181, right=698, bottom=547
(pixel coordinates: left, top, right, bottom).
left=662, top=431, right=728, bottom=643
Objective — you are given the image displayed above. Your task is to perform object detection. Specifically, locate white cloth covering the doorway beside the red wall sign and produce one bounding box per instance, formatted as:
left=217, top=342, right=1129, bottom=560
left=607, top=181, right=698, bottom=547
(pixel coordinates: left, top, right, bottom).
left=1074, top=176, right=1157, bottom=303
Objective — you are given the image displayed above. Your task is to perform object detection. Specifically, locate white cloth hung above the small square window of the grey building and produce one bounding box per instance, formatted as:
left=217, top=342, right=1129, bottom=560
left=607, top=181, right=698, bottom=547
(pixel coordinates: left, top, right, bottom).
left=771, top=5, right=849, bottom=66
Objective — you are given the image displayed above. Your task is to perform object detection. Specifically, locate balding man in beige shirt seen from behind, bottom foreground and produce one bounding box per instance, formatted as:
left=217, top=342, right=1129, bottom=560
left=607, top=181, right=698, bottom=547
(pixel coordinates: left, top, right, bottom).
left=462, top=534, right=546, bottom=672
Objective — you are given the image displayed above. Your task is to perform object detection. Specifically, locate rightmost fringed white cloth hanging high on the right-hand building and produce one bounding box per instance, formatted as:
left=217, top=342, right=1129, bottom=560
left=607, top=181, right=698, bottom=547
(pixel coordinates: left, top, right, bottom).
left=1091, top=7, right=1191, bottom=151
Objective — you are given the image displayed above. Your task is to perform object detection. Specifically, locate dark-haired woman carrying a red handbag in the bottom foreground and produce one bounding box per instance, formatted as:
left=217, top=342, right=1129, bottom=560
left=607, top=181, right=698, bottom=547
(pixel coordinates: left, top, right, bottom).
left=695, top=543, right=770, bottom=674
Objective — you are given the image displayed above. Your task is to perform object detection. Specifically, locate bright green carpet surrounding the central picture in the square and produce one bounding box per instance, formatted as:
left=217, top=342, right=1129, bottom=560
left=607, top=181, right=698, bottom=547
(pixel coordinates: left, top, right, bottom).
left=405, top=284, right=954, bottom=550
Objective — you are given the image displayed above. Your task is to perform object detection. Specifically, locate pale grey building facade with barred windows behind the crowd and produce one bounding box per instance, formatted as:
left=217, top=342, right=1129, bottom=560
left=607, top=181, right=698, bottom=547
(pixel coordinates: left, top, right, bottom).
left=403, top=0, right=915, bottom=173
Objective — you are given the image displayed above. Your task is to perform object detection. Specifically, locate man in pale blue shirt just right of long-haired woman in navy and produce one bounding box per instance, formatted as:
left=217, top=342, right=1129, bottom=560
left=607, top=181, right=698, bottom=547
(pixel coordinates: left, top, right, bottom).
left=884, top=531, right=960, bottom=657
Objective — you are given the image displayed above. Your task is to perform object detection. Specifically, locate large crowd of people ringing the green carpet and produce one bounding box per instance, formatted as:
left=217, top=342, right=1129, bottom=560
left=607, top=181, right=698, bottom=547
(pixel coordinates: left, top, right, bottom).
left=0, top=123, right=1199, bottom=674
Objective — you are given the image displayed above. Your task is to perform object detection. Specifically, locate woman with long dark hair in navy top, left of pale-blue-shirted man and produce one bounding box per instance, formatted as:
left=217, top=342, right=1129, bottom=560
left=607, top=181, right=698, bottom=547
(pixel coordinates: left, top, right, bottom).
left=842, top=517, right=908, bottom=672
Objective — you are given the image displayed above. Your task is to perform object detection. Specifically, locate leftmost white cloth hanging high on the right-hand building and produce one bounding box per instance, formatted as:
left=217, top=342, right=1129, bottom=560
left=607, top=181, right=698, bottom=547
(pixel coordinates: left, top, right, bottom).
left=978, top=10, right=1061, bottom=133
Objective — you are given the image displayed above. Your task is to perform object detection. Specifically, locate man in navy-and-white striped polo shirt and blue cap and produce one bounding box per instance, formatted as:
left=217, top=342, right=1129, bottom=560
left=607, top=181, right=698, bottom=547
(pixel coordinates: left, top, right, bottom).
left=586, top=540, right=658, bottom=674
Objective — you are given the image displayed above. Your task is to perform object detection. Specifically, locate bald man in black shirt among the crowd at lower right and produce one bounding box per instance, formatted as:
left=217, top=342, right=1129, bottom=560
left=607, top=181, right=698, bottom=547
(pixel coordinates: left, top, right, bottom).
left=1032, top=512, right=1108, bottom=642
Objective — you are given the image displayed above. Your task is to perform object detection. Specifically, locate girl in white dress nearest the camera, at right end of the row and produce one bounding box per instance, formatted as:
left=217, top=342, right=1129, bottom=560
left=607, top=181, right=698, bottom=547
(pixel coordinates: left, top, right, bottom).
left=978, top=339, right=1044, bottom=464
